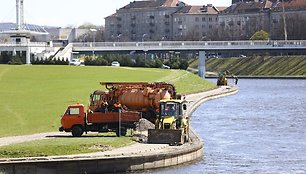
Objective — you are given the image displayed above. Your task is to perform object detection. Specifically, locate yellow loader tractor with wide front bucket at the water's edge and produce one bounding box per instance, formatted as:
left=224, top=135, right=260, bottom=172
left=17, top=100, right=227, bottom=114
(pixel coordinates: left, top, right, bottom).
left=148, top=99, right=189, bottom=145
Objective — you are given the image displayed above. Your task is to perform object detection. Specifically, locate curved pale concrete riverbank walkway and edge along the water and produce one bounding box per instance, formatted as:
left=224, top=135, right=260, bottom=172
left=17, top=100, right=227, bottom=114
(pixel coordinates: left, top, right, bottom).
left=0, top=86, right=238, bottom=174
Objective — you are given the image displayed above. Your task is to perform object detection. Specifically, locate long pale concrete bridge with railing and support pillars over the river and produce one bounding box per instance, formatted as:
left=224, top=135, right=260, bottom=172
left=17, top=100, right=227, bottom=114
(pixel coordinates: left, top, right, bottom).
left=0, top=40, right=306, bottom=78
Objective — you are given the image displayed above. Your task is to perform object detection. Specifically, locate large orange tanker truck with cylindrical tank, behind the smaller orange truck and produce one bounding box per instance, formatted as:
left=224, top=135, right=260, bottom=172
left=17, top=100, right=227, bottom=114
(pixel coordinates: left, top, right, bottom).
left=97, top=82, right=181, bottom=123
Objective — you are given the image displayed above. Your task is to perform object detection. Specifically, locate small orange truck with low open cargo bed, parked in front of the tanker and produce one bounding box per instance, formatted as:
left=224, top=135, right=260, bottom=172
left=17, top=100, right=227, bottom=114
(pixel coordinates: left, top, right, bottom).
left=59, top=104, right=140, bottom=137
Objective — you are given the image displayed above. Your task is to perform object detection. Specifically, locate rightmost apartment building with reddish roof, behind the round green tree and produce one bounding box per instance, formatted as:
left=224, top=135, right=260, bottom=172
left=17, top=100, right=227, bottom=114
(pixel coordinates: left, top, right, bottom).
left=218, top=0, right=306, bottom=40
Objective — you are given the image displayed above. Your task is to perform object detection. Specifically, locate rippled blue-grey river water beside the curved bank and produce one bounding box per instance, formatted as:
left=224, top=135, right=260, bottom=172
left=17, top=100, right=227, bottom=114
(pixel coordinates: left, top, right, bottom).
left=154, top=79, right=306, bottom=174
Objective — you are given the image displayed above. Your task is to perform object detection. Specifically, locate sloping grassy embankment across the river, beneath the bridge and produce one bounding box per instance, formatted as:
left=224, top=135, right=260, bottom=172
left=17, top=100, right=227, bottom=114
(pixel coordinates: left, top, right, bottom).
left=192, top=56, right=306, bottom=76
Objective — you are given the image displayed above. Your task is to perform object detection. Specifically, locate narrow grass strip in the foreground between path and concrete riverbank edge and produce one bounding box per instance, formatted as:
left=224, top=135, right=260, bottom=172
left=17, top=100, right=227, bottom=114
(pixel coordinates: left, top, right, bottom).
left=0, top=134, right=135, bottom=158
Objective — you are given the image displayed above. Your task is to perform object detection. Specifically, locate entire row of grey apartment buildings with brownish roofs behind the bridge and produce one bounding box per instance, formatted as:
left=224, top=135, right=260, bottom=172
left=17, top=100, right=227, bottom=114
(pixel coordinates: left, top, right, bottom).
left=105, top=0, right=306, bottom=42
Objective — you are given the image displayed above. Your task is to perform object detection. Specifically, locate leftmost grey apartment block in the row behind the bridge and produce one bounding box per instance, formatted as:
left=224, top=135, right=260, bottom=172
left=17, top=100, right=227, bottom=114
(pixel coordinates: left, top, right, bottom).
left=105, top=0, right=185, bottom=41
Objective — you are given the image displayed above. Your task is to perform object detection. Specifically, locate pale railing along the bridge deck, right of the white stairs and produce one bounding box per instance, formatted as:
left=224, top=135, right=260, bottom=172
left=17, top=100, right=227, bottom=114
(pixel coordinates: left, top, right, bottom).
left=72, top=40, right=306, bottom=50
